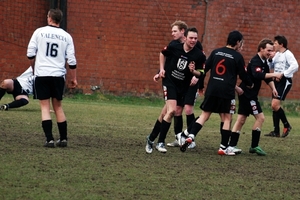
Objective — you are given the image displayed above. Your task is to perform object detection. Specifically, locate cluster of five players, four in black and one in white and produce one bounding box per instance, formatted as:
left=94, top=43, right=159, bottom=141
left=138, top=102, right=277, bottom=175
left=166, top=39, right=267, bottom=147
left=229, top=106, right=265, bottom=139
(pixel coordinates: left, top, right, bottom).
left=145, top=21, right=298, bottom=156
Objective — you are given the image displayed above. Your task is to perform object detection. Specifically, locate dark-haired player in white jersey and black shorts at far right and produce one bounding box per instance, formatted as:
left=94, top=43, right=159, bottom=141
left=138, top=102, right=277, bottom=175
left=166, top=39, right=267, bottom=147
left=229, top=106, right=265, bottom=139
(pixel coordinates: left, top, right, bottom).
left=265, top=35, right=299, bottom=137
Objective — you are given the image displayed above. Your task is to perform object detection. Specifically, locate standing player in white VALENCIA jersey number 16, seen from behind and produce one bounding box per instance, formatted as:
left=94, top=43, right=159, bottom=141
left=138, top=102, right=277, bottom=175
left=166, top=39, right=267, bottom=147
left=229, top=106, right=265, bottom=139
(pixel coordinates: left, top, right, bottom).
left=27, top=9, right=77, bottom=147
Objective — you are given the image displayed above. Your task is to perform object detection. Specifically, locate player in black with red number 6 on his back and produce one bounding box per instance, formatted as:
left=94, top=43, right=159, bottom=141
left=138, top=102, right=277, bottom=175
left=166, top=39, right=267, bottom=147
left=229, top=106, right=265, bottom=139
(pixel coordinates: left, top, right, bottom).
left=177, top=31, right=253, bottom=155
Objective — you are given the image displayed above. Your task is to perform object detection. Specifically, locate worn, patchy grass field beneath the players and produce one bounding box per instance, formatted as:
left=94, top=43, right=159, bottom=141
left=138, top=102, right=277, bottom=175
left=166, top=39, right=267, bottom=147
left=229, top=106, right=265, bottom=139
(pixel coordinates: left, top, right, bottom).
left=0, top=95, right=300, bottom=200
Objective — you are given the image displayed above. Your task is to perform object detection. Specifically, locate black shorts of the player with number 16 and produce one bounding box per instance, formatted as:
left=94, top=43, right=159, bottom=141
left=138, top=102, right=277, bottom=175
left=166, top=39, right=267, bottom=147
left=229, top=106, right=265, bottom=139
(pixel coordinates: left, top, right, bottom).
left=34, top=76, right=65, bottom=100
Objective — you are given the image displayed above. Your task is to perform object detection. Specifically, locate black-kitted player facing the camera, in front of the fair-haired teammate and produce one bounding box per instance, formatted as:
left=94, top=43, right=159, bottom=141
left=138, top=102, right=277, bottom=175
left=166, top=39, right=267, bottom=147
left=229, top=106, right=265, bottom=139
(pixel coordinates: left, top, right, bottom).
left=146, top=27, right=205, bottom=153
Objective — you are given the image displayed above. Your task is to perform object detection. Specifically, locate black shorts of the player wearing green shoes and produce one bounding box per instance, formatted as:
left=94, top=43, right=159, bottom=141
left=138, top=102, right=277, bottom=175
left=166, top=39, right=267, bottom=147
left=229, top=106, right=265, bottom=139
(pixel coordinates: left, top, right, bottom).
left=238, top=95, right=262, bottom=116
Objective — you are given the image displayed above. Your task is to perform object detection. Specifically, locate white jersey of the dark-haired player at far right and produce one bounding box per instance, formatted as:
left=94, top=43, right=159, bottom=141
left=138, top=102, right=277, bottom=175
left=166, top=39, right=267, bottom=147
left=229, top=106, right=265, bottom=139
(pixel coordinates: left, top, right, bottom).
left=270, top=49, right=299, bottom=78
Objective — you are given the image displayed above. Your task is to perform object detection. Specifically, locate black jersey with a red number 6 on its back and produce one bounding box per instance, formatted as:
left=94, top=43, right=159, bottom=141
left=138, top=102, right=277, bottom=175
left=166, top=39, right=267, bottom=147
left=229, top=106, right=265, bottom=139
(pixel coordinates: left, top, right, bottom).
left=205, top=47, right=252, bottom=99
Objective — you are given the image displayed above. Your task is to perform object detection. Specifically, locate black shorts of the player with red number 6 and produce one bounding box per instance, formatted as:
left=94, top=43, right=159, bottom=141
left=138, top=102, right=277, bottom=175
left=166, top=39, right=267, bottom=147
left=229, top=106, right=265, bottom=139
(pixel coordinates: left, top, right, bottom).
left=200, top=96, right=235, bottom=114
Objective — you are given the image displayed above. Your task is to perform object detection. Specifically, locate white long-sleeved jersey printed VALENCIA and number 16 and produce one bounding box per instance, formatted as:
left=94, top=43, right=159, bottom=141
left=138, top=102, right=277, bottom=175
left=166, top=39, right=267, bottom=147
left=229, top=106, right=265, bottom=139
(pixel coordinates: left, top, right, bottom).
left=27, top=26, right=76, bottom=77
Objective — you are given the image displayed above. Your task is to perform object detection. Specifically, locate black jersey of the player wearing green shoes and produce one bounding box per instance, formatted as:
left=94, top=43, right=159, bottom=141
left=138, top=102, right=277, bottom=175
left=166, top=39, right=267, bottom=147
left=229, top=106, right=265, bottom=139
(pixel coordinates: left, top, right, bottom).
left=240, top=54, right=272, bottom=100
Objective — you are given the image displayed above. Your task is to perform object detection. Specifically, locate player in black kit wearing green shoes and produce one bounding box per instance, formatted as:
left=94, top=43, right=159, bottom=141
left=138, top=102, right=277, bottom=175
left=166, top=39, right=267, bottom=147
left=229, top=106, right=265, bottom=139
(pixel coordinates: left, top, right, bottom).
left=228, top=39, right=281, bottom=156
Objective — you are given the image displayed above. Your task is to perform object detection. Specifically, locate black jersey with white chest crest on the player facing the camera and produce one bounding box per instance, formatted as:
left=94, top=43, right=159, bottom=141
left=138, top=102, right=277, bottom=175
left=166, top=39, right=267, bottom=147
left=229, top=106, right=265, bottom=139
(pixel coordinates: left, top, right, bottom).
left=161, top=43, right=206, bottom=93
